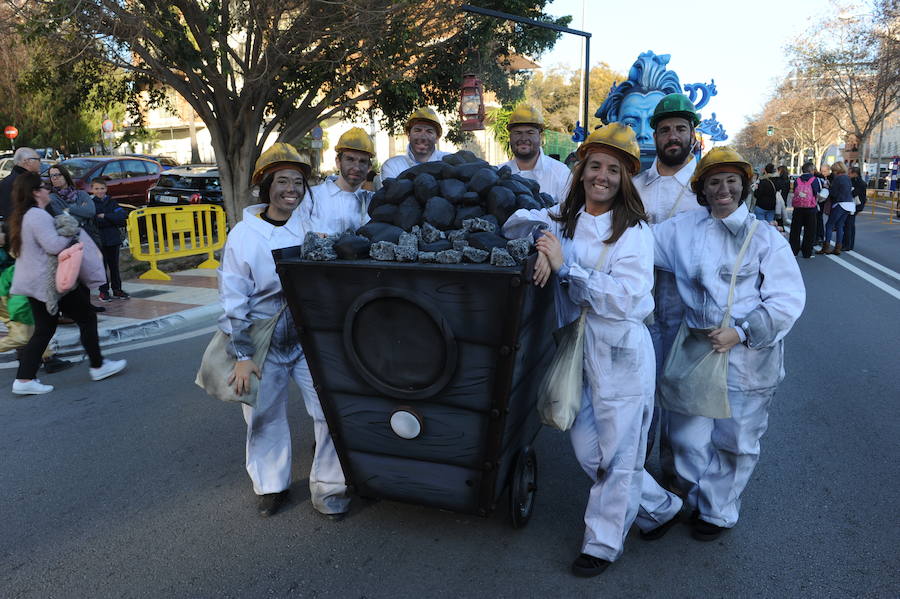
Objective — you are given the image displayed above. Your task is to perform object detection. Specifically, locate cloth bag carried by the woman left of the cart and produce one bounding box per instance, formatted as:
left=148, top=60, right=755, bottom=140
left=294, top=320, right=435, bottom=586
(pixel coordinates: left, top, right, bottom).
left=194, top=306, right=285, bottom=408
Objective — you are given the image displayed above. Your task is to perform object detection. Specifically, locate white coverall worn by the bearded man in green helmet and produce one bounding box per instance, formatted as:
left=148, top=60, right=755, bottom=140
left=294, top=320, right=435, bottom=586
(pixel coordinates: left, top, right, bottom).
left=632, top=158, right=700, bottom=477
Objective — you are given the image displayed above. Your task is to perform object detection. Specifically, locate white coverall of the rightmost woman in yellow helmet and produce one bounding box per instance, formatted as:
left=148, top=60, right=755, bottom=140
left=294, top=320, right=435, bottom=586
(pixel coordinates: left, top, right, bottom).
left=653, top=204, right=806, bottom=528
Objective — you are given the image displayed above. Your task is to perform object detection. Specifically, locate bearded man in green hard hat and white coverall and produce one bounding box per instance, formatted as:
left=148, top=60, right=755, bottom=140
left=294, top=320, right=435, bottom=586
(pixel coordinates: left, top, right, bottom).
left=634, top=94, right=700, bottom=488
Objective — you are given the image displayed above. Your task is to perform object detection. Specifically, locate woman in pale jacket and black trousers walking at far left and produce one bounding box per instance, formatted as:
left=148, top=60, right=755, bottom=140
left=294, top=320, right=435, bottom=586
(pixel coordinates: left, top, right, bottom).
left=8, top=173, right=126, bottom=395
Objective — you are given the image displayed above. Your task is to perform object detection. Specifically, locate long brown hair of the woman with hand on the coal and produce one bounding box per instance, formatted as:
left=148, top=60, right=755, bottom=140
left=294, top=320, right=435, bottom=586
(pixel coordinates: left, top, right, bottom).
left=550, top=154, right=647, bottom=243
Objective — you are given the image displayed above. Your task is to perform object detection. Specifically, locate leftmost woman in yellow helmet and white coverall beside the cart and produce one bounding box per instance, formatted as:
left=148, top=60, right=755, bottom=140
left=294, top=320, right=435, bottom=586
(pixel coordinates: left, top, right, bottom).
left=219, top=143, right=349, bottom=519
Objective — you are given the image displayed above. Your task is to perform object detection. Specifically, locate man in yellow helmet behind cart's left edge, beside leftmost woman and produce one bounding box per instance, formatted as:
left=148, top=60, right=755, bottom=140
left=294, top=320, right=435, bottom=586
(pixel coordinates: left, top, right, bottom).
left=300, top=127, right=375, bottom=235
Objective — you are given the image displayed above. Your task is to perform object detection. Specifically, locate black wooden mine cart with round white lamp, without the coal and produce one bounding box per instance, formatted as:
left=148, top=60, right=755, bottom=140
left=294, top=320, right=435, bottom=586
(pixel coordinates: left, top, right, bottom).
left=275, top=249, right=555, bottom=527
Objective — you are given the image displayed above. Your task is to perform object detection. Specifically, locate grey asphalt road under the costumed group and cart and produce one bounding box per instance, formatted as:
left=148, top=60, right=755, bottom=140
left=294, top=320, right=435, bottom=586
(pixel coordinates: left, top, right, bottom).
left=0, top=211, right=900, bottom=598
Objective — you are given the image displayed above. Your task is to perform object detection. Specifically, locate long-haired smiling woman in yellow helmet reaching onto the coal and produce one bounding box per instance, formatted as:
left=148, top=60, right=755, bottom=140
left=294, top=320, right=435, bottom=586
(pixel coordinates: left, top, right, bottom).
left=503, top=123, right=682, bottom=576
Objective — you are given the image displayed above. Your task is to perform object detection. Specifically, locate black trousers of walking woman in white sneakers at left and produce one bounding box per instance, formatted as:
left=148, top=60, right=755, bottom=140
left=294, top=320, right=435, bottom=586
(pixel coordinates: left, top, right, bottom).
left=16, top=285, right=103, bottom=381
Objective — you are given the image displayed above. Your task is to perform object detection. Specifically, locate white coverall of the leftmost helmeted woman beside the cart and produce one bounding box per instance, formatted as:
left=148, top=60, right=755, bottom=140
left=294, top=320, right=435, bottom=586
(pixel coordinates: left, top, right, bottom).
left=219, top=204, right=350, bottom=514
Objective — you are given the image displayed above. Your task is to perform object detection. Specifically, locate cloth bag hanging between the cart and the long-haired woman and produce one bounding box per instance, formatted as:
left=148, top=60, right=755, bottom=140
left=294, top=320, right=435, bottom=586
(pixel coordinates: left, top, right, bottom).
left=537, top=243, right=609, bottom=432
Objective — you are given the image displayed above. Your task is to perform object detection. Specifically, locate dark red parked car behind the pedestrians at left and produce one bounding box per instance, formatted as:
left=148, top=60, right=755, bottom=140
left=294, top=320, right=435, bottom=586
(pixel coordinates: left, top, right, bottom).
left=59, top=156, right=162, bottom=208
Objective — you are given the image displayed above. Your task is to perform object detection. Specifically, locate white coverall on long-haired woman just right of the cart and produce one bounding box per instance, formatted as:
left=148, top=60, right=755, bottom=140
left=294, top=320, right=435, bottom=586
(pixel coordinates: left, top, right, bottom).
left=503, top=206, right=682, bottom=561
